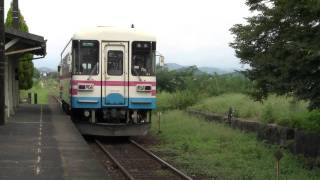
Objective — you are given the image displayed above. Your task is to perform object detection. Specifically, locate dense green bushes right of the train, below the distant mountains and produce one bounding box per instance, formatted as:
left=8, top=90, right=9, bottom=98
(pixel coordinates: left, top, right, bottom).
left=157, top=66, right=252, bottom=97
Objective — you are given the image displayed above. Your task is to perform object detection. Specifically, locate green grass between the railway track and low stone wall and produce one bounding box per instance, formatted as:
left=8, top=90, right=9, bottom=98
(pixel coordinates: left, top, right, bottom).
left=152, top=110, right=320, bottom=180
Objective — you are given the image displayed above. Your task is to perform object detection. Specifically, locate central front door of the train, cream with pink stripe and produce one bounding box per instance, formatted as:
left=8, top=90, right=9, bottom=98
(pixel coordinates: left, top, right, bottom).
left=101, top=42, right=128, bottom=107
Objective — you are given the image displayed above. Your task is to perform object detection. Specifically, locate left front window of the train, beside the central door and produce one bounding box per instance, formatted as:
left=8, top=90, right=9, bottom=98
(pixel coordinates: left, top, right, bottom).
left=72, top=40, right=99, bottom=75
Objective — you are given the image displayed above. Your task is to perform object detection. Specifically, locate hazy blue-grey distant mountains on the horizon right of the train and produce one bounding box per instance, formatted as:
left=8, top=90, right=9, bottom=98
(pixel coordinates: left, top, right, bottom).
left=165, top=63, right=235, bottom=74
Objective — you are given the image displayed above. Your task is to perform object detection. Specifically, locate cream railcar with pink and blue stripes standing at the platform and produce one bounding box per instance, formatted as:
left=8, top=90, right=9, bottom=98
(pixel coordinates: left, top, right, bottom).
left=58, top=27, right=156, bottom=136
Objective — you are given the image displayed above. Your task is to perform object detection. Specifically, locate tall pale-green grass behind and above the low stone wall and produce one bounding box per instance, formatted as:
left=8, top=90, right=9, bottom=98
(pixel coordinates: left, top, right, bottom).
left=157, top=91, right=320, bottom=132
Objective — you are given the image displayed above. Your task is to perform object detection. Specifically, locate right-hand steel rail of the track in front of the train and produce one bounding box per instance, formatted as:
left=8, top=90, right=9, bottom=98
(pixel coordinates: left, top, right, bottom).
left=129, top=139, right=192, bottom=180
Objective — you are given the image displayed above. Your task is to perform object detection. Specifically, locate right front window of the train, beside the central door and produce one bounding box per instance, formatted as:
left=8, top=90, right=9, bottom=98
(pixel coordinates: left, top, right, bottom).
left=131, top=41, right=156, bottom=76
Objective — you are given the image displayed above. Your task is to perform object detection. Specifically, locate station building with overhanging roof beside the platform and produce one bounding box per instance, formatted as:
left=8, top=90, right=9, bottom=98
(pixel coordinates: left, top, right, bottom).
left=0, top=0, right=46, bottom=124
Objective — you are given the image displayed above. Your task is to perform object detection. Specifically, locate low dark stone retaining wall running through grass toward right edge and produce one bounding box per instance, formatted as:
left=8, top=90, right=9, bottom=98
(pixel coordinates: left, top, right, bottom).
left=187, top=110, right=320, bottom=166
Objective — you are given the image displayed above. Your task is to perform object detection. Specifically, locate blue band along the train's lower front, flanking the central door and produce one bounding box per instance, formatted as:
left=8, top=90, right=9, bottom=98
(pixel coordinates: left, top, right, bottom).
left=71, top=97, right=156, bottom=109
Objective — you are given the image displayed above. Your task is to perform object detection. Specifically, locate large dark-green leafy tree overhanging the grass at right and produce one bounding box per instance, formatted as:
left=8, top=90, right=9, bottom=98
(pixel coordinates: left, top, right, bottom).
left=230, top=0, right=320, bottom=109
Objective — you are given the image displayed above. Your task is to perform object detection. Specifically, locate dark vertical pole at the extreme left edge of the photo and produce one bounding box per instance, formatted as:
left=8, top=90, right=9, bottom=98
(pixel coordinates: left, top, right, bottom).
left=0, top=0, right=5, bottom=125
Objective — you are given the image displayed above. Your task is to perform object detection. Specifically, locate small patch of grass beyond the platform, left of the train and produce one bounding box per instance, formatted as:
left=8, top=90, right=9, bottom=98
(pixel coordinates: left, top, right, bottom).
left=20, top=79, right=58, bottom=104
